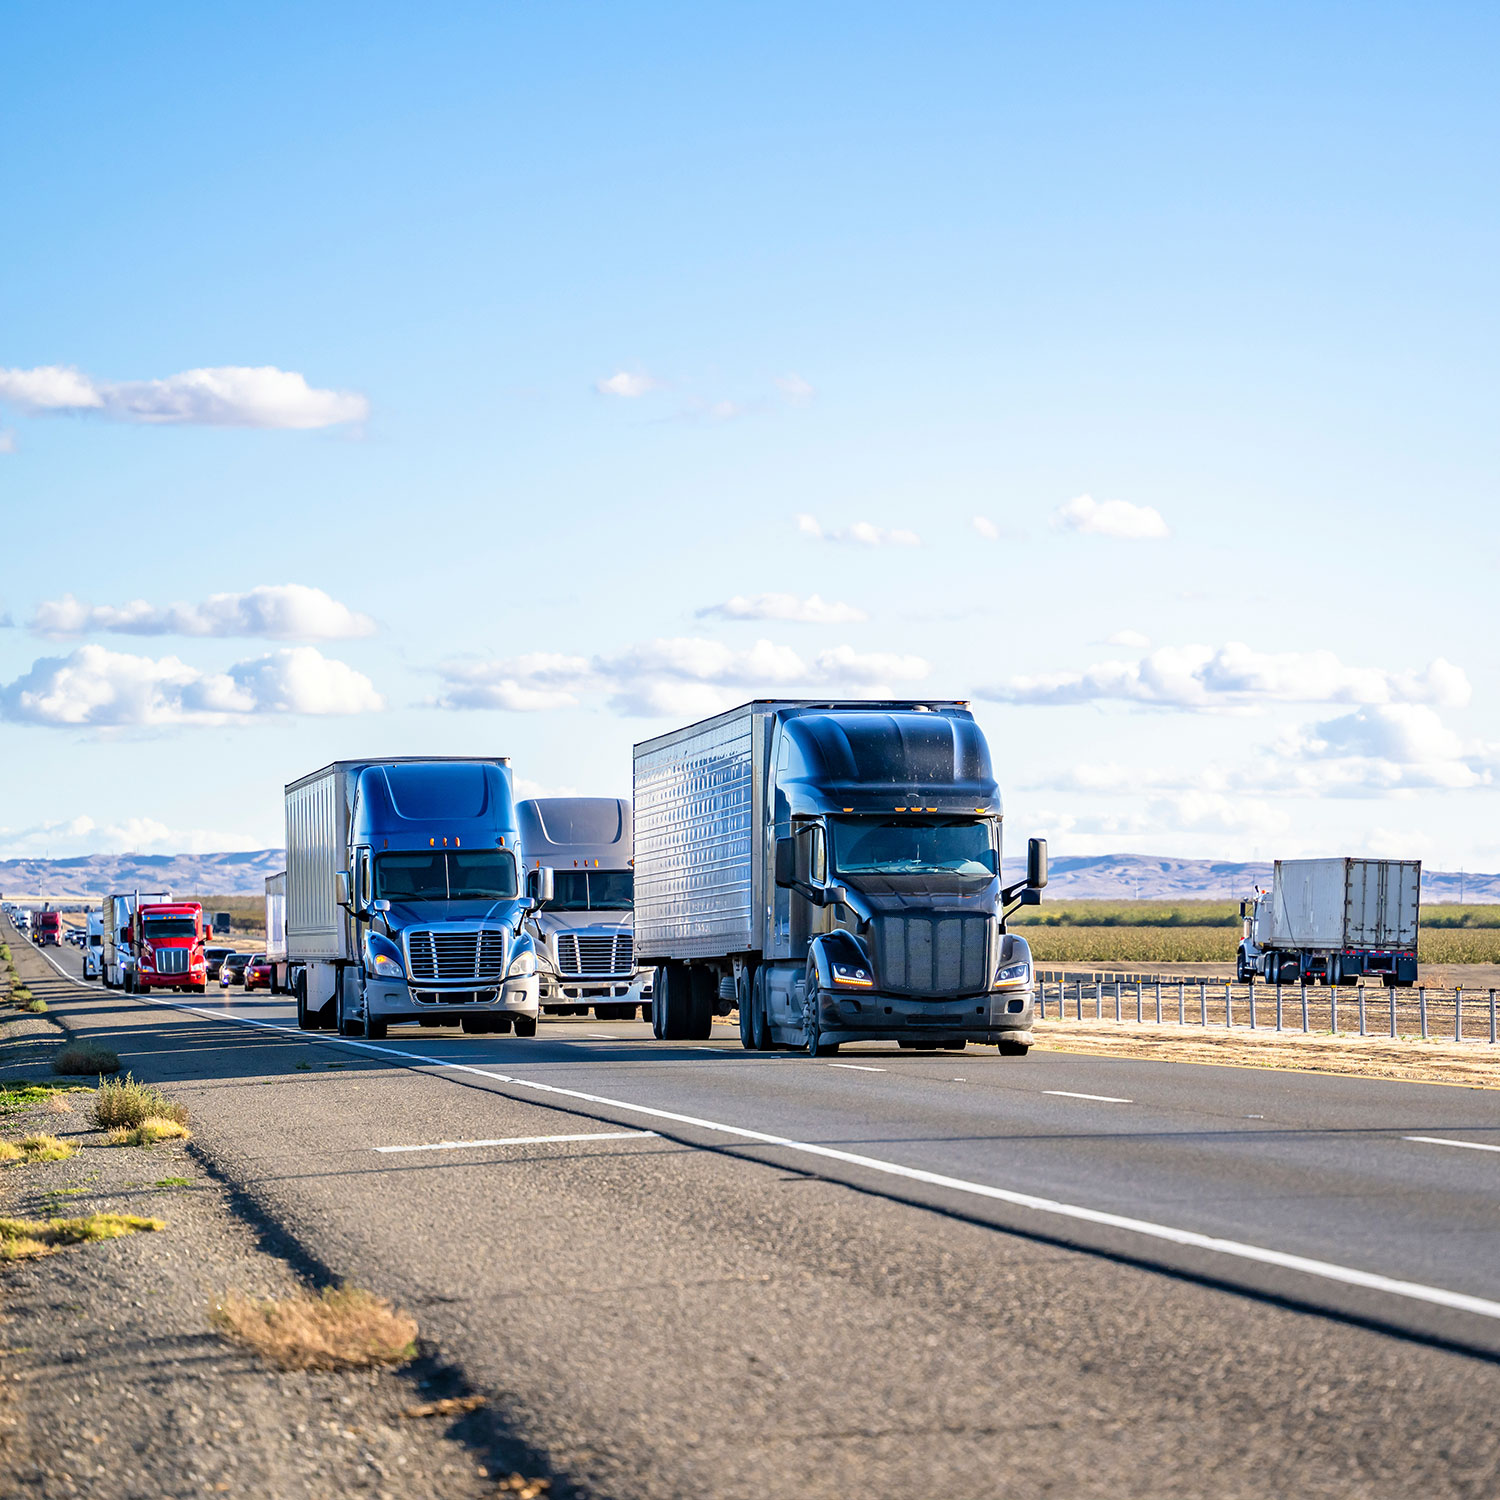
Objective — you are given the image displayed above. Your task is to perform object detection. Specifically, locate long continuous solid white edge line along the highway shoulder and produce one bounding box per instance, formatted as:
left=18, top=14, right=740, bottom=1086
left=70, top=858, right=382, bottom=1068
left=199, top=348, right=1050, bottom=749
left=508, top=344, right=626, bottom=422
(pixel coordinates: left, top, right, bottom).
left=108, top=995, right=1500, bottom=1320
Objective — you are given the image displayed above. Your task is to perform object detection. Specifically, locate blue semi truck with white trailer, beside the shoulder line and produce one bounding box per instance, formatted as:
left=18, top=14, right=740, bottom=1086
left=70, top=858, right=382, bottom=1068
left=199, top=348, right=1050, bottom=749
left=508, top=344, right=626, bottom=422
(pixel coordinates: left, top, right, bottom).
left=287, top=758, right=552, bottom=1037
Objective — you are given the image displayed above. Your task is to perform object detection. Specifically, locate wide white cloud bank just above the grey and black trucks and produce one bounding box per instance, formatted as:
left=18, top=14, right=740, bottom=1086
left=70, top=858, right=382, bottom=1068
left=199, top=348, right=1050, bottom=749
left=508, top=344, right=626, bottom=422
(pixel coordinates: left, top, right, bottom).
left=437, top=636, right=930, bottom=717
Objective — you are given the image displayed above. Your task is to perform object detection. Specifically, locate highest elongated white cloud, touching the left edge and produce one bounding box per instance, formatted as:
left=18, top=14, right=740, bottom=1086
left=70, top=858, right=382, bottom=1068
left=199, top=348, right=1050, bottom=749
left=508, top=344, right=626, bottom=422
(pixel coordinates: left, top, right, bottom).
left=0, top=365, right=369, bottom=428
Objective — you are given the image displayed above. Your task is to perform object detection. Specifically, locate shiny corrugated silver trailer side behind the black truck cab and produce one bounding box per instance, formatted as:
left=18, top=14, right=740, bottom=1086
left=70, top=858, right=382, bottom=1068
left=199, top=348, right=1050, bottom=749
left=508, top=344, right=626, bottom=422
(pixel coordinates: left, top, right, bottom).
left=635, top=704, right=774, bottom=963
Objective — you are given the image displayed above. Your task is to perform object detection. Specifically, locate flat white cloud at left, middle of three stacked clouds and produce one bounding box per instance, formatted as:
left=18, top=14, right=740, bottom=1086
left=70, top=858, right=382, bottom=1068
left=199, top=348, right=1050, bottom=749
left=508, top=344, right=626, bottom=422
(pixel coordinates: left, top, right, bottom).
left=30, top=584, right=375, bottom=641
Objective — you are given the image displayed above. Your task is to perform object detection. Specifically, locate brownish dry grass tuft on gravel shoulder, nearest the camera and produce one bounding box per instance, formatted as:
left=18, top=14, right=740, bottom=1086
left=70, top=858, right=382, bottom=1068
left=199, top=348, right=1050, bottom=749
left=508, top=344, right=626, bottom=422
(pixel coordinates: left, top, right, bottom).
left=209, top=1287, right=417, bottom=1370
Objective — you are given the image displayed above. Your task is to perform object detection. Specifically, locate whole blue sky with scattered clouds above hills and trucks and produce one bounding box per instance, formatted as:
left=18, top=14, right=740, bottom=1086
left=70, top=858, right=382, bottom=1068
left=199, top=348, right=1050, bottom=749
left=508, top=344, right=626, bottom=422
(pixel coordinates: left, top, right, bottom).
left=0, top=5, right=1500, bottom=869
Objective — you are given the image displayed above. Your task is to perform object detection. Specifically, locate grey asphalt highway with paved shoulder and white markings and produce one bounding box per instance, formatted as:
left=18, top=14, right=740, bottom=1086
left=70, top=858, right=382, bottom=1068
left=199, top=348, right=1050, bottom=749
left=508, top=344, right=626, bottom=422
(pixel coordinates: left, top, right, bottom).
left=14, top=930, right=1500, bottom=1496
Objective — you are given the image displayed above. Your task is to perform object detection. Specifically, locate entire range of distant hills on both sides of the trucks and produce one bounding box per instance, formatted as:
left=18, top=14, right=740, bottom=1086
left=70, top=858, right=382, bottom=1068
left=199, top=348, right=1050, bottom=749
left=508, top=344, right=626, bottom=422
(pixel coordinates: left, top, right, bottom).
left=0, top=849, right=1500, bottom=903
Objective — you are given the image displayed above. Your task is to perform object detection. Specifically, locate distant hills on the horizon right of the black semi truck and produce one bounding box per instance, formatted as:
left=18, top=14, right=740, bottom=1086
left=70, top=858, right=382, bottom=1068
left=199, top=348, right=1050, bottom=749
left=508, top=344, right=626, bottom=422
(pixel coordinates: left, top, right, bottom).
left=1044, top=854, right=1500, bottom=905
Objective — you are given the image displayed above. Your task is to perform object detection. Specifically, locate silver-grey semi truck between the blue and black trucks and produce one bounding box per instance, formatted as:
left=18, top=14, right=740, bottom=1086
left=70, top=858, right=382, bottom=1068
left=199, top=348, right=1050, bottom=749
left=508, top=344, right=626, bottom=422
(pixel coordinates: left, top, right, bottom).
left=516, top=797, right=651, bottom=1022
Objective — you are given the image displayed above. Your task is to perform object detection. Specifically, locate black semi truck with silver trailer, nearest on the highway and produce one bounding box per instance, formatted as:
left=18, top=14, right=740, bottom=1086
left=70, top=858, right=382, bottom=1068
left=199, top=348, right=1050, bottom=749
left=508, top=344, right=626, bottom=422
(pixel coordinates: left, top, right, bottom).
left=635, top=701, right=1047, bottom=1056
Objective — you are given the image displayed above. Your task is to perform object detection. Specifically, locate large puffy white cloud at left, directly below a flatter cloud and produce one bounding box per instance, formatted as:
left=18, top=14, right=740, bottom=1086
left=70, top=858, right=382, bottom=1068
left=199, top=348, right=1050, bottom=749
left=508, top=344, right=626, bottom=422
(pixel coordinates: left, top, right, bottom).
left=0, top=645, right=384, bottom=728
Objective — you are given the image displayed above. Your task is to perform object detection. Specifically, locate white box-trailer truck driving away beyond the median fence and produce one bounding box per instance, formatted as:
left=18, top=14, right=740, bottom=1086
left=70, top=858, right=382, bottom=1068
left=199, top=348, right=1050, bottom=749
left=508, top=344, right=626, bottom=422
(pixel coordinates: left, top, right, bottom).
left=1235, top=858, right=1422, bottom=989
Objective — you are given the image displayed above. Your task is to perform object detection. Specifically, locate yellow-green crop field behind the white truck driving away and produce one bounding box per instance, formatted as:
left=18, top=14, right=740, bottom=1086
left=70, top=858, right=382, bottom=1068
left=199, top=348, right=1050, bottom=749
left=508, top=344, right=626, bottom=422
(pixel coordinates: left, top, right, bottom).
left=1011, top=902, right=1500, bottom=965
